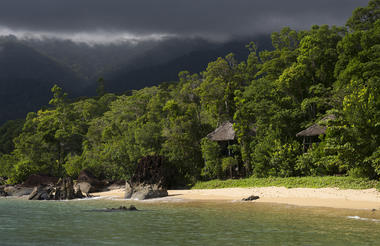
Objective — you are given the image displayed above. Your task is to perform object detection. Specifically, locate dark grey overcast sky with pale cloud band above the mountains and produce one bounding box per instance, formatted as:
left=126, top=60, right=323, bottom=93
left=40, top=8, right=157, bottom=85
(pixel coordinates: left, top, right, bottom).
left=0, top=0, right=368, bottom=43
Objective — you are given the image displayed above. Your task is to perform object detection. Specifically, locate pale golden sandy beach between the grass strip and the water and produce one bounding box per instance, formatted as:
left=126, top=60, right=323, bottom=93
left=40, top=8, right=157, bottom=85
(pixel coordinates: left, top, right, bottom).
left=92, top=187, right=380, bottom=210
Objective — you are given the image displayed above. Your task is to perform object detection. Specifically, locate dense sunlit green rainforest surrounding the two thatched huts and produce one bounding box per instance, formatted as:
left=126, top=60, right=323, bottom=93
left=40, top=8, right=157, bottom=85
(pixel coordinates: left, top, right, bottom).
left=0, top=0, right=380, bottom=185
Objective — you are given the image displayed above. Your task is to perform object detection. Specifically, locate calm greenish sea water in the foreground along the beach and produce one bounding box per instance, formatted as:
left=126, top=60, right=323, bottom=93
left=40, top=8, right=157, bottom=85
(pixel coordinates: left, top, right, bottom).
left=0, top=198, right=380, bottom=246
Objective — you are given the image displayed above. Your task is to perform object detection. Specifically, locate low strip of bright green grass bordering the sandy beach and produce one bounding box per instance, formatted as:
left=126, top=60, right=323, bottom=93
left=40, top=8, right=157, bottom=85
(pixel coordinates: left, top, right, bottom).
left=192, top=176, right=380, bottom=190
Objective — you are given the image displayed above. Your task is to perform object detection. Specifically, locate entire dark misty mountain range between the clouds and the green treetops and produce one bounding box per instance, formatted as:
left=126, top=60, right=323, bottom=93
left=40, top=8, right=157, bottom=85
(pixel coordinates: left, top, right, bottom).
left=0, top=36, right=270, bottom=124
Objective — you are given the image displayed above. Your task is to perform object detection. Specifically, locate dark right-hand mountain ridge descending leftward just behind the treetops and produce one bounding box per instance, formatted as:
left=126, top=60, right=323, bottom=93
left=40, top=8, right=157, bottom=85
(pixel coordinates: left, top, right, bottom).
left=102, top=35, right=272, bottom=92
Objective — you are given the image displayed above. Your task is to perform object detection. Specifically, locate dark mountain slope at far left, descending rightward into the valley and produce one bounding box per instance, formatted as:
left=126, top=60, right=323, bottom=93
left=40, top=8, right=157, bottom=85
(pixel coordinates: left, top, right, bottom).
left=0, top=39, right=83, bottom=123
